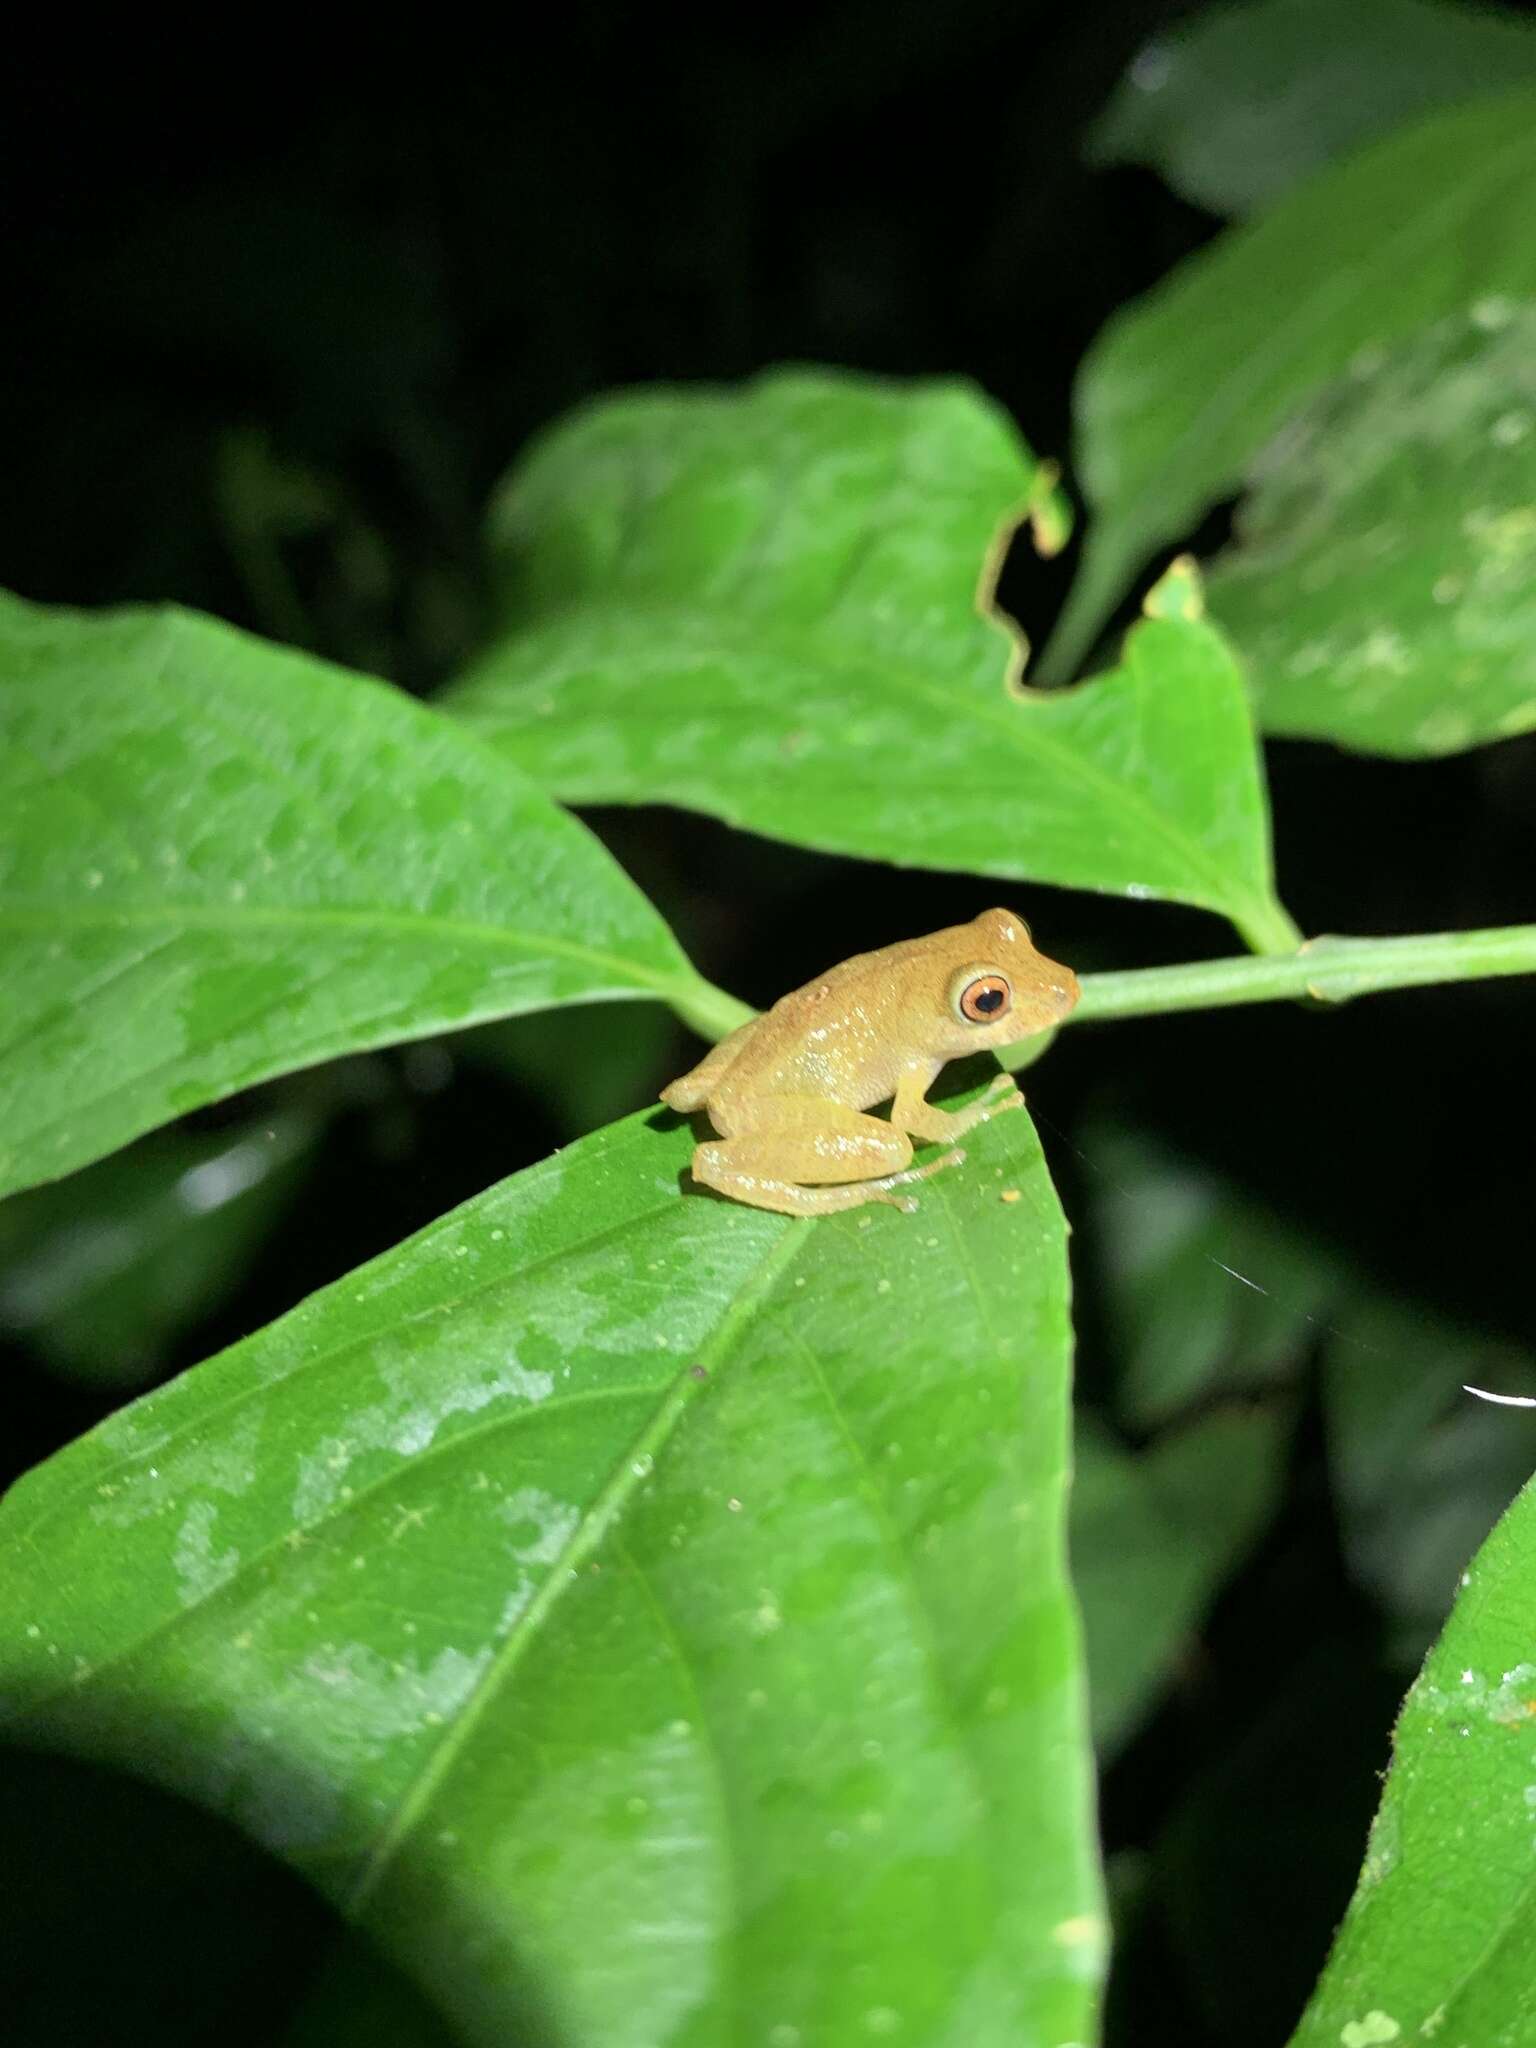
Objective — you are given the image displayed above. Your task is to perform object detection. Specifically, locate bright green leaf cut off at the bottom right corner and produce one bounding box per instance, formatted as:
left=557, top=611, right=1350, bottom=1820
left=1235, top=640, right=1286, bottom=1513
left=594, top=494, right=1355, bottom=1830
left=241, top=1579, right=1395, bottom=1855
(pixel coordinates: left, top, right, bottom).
left=1292, top=1466, right=1536, bottom=2048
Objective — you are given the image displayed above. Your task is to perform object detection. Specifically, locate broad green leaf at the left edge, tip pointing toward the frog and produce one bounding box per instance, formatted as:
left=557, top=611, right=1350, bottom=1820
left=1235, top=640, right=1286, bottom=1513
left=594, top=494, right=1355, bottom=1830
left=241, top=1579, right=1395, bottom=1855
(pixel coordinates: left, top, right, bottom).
left=0, top=598, right=702, bottom=1192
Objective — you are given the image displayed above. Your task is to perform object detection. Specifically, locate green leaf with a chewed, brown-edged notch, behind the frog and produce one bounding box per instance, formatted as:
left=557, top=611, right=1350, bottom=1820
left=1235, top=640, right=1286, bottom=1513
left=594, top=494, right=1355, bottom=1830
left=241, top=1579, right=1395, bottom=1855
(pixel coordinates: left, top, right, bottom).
left=449, top=371, right=1292, bottom=946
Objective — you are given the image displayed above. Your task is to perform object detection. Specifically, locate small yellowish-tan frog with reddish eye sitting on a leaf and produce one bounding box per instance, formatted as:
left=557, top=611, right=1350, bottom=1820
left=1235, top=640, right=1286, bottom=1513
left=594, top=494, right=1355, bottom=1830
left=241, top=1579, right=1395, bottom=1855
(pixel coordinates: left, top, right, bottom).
left=662, top=909, right=1077, bottom=1217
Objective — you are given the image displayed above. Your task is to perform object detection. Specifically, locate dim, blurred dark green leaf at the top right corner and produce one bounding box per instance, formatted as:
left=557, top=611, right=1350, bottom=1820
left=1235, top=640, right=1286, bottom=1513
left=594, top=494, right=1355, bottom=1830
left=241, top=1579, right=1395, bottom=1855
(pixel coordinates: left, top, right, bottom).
left=1087, top=0, right=1536, bottom=213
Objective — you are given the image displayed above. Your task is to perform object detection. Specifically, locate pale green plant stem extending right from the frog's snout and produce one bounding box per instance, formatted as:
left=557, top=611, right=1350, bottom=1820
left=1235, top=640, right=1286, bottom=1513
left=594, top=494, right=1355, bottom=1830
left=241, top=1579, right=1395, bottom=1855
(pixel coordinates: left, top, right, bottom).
left=1069, top=924, right=1536, bottom=1024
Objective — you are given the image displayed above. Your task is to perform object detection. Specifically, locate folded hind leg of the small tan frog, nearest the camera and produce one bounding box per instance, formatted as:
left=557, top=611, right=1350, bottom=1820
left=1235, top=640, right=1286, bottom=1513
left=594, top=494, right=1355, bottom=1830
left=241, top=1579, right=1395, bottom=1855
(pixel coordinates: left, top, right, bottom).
left=692, top=1096, right=963, bottom=1217
